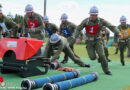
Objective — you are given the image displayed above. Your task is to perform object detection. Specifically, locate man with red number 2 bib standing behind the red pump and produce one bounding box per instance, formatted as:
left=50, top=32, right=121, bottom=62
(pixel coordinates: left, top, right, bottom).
left=23, top=4, right=44, bottom=56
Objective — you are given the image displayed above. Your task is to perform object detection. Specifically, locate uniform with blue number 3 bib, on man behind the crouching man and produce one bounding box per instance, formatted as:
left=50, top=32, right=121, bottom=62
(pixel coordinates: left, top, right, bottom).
left=60, top=21, right=76, bottom=63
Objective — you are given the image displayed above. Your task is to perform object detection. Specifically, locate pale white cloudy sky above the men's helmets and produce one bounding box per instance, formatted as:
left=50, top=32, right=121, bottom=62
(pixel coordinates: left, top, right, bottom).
left=0, top=0, right=130, bottom=35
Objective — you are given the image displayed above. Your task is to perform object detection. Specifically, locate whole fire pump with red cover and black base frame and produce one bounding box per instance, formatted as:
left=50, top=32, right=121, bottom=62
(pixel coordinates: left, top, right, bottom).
left=0, top=37, right=50, bottom=77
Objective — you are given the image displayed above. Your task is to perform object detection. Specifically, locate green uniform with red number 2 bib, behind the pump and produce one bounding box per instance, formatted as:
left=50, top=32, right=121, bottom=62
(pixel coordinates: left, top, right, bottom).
left=23, top=13, right=44, bottom=40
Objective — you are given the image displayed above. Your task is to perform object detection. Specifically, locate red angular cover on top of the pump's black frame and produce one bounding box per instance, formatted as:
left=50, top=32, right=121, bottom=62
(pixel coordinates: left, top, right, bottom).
left=0, top=37, right=43, bottom=60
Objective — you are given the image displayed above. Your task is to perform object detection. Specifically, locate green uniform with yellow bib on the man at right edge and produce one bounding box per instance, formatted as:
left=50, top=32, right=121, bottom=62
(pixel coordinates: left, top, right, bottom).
left=118, top=24, right=130, bottom=66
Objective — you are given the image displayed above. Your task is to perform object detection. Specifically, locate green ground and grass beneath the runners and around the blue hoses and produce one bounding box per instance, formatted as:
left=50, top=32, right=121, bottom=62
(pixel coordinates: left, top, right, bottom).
left=0, top=44, right=130, bottom=90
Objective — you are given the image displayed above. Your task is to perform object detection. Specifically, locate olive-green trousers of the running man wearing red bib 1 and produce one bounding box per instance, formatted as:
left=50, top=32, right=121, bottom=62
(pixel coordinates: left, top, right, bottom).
left=86, top=39, right=109, bottom=73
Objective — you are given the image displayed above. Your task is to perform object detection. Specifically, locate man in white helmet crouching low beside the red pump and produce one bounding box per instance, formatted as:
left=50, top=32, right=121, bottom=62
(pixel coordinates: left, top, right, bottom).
left=43, top=33, right=90, bottom=67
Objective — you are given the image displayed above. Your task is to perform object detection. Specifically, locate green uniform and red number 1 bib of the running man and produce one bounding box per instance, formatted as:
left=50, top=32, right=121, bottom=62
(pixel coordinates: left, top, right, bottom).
left=76, top=17, right=119, bottom=74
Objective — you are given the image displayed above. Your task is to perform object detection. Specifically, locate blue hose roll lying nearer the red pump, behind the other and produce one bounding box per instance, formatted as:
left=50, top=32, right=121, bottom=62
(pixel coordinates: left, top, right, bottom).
left=21, top=71, right=80, bottom=90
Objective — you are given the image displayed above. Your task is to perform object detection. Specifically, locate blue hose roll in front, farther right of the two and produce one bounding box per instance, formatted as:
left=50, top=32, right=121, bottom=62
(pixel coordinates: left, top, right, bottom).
left=43, top=72, right=98, bottom=90
